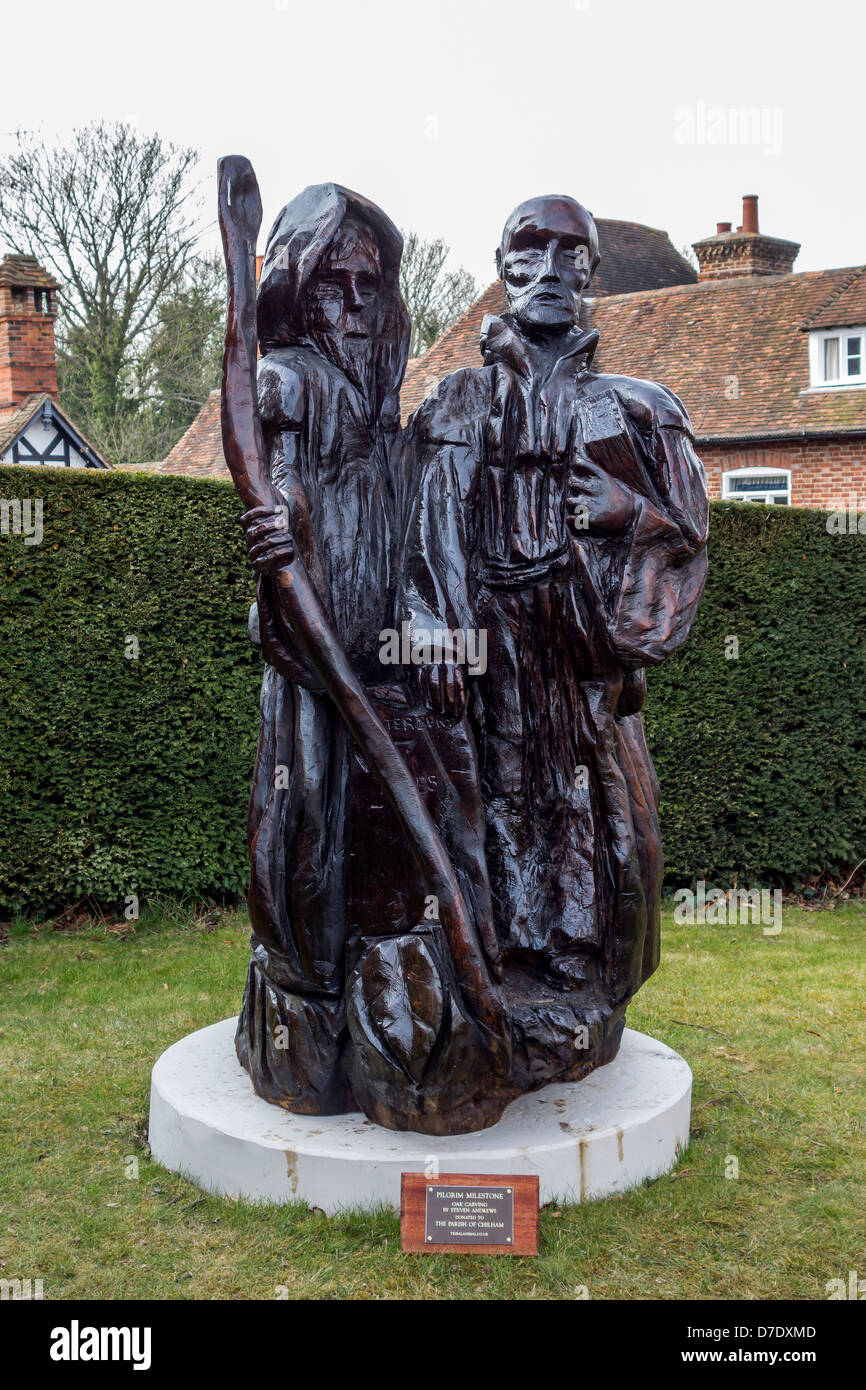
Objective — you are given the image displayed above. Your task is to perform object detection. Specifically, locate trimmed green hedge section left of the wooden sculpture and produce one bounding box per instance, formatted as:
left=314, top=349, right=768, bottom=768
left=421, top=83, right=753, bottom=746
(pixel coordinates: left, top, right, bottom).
left=0, top=467, right=261, bottom=912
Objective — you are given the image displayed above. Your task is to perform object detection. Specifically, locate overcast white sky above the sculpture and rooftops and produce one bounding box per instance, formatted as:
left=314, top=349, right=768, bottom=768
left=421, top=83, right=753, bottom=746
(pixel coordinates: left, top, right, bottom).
left=0, top=0, right=866, bottom=284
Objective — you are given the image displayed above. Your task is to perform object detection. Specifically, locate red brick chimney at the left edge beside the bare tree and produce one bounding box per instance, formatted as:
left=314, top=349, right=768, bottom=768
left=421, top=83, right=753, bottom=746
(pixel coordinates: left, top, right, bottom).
left=0, top=256, right=57, bottom=420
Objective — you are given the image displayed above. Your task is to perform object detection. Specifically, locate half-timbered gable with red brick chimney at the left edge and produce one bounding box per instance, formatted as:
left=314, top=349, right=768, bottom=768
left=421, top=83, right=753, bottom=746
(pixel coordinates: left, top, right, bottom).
left=0, top=256, right=108, bottom=468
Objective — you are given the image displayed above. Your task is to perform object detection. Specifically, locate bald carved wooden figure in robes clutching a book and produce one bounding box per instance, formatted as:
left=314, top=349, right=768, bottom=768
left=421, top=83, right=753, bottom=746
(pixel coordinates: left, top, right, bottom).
left=398, top=197, right=708, bottom=1091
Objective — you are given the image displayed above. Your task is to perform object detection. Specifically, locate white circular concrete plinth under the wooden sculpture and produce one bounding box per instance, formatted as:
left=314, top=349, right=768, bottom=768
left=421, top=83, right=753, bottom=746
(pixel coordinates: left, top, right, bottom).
left=149, top=1019, right=692, bottom=1213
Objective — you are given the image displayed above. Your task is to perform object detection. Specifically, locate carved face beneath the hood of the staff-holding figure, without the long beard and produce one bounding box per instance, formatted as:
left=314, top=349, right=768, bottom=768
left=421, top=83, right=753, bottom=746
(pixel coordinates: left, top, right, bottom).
left=307, top=220, right=382, bottom=342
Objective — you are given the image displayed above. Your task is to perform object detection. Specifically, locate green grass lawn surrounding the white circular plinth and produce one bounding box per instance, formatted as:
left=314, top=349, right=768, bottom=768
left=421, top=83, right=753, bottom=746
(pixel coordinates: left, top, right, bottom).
left=0, top=904, right=866, bottom=1298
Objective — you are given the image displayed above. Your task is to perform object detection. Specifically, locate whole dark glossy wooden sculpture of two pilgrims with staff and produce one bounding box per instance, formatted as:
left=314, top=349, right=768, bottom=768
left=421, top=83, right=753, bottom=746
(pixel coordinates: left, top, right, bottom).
left=220, top=165, right=708, bottom=1134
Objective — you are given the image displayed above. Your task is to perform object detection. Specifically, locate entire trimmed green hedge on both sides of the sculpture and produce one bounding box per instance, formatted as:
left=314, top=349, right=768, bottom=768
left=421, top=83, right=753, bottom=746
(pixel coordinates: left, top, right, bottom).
left=0, top=467, right=866, bottom=913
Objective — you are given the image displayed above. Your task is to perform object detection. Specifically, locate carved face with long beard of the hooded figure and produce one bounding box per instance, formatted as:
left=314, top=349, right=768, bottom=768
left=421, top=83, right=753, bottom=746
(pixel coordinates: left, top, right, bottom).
left=306, top=218, right=382, bottom=400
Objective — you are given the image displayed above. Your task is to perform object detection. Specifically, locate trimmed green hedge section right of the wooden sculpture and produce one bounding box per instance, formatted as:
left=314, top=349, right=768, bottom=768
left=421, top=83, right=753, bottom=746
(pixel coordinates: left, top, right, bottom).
left=646, top=502, right=866, bottom=888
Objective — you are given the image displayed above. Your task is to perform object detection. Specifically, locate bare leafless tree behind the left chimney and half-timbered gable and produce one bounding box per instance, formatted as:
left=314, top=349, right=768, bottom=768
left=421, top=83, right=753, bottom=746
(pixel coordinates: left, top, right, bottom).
left=0, top=122, right=197, bottom=461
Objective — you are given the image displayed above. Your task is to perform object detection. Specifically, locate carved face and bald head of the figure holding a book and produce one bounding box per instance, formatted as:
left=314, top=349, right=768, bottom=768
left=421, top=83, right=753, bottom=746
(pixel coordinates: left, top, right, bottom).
left=496, top=197, right=598, bottom=334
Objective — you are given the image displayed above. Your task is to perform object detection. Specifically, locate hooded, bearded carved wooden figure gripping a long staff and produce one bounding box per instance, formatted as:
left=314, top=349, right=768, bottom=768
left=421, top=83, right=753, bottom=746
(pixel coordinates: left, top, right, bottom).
left=236, top=183, right=409, bottom=1113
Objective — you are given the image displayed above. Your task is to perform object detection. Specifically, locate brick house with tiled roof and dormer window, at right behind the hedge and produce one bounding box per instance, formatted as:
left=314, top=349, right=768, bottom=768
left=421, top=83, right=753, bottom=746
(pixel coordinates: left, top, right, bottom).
left=402, top=195, right=866, bottom=510
